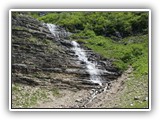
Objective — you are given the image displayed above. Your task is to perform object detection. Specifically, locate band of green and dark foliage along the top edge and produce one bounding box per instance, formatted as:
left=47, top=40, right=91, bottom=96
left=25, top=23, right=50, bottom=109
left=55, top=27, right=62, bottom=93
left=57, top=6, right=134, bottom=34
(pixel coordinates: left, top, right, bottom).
left=38, top=12, right=148, bottom=37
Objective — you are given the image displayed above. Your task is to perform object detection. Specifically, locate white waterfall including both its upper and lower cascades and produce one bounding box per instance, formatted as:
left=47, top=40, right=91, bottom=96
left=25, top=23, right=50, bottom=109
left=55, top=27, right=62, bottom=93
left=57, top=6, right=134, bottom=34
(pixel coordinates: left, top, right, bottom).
left=47, top=24, right=102, bottom=86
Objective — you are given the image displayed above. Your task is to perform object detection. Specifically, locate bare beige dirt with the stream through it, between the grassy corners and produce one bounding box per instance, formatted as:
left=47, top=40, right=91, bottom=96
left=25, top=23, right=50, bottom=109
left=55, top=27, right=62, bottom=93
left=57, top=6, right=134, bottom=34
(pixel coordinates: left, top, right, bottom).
left=35, top=68, right=132, bottom=108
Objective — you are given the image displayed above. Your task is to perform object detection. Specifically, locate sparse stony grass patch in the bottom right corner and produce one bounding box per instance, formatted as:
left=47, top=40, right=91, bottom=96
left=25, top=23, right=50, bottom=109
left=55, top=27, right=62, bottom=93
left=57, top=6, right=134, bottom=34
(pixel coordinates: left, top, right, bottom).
left=119, top=75, right=148, bottom=108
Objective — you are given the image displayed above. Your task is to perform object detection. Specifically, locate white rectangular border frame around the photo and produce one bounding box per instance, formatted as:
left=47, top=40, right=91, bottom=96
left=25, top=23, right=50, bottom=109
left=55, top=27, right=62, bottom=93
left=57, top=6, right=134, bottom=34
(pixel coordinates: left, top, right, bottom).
left=9, top=9, right=151, bottom=111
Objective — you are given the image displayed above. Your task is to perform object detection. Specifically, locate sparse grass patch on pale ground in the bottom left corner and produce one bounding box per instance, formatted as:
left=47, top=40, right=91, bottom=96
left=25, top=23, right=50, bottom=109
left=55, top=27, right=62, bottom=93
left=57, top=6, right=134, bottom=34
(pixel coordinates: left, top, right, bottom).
left=12, top=83, right=60, bottom=108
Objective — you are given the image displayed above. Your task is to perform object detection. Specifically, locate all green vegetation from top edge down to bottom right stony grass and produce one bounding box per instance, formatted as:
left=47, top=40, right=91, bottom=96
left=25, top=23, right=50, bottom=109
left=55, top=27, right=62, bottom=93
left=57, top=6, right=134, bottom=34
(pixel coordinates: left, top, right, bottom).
left=26, top=12, right=149, bottom=108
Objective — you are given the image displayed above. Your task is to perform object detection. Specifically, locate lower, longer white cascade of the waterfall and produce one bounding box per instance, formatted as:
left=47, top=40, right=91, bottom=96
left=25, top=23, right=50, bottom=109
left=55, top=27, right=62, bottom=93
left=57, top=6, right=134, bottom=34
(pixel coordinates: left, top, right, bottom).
left=72, top=41, right=102, bottom=86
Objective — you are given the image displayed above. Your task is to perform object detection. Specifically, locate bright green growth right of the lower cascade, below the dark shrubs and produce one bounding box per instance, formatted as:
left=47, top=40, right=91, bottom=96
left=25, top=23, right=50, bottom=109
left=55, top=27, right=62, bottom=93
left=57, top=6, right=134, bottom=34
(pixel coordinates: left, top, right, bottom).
left=78, top=35, right=148, bottom=76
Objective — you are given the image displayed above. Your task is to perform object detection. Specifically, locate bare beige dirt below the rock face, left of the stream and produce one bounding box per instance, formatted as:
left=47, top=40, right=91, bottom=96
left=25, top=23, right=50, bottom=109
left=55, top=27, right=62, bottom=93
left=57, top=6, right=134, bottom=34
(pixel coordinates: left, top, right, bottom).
left=35, top=90, right=89, bottom=108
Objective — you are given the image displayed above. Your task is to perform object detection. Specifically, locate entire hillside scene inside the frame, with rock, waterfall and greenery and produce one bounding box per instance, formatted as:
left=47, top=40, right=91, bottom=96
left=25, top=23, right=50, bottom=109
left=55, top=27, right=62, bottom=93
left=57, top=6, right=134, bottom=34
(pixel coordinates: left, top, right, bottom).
left=12, top=12, right=148, bottom=108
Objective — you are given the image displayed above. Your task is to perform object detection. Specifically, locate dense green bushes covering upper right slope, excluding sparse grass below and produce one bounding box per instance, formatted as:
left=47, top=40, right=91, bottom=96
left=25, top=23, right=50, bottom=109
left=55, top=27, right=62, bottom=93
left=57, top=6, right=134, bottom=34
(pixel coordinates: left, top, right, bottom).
left=34, top=12, right=148, bottom=74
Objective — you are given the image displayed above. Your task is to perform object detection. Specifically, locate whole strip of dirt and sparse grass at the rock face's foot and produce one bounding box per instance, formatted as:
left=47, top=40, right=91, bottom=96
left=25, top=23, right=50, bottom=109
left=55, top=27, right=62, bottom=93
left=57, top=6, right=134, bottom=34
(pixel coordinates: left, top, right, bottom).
left=12, top=67, right=148, bottom=108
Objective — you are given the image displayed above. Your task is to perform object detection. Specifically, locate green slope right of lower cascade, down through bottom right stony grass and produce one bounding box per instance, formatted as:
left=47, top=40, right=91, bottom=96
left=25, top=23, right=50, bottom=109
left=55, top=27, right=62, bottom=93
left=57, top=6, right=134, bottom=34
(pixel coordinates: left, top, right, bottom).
left=79, top=35, right=148, bottom=108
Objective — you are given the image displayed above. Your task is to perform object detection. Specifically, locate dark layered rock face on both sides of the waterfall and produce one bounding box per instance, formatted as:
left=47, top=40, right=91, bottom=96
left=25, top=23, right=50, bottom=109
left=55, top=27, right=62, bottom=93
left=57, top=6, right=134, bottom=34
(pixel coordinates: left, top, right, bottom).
left=11, top=14, right=120, bottom=90
